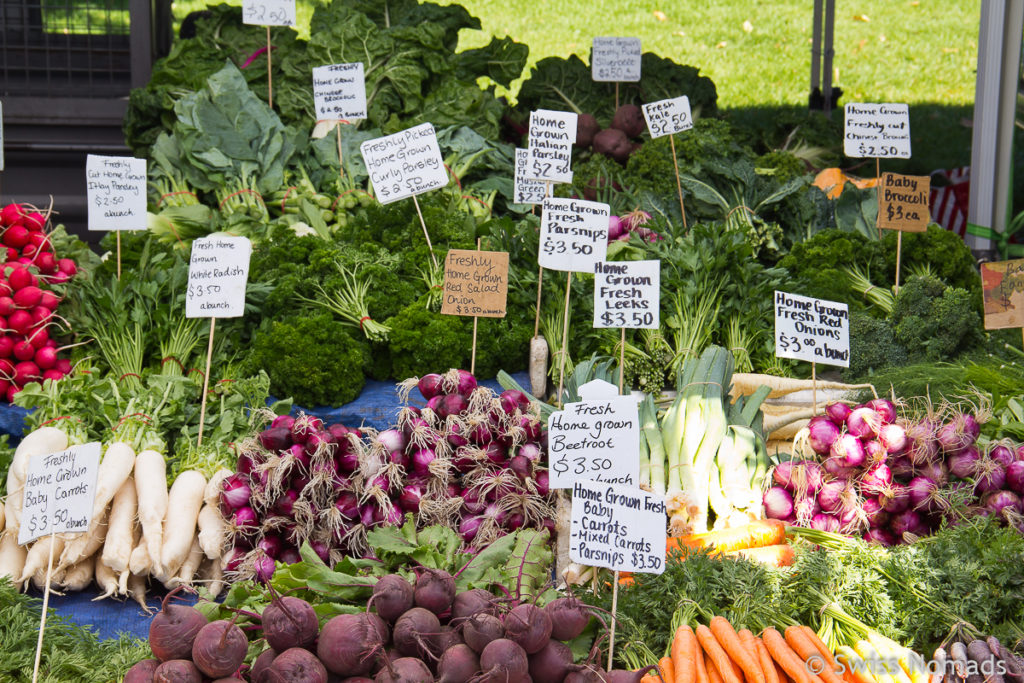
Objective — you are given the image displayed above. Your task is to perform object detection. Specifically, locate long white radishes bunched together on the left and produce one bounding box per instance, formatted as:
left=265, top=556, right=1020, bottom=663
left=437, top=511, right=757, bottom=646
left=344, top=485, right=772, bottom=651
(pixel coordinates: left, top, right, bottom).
left=0, top=427, right=230, bottom=609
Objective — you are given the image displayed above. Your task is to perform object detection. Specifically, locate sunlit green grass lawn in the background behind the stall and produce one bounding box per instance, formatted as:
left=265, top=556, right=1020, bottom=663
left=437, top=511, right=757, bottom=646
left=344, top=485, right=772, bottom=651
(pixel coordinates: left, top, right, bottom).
left=173, top=0, right=999, bottom=187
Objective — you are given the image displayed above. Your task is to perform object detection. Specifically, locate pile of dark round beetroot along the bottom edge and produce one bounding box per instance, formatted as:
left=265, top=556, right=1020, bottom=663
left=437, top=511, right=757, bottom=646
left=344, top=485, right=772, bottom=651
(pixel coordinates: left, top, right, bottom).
left=124, top=568, right=618, bottom=683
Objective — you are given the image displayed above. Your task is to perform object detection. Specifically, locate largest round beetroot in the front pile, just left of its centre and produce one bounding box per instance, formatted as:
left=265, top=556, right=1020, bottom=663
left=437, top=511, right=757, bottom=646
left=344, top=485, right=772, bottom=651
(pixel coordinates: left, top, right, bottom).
left=316, top=612, right=388, bottom=676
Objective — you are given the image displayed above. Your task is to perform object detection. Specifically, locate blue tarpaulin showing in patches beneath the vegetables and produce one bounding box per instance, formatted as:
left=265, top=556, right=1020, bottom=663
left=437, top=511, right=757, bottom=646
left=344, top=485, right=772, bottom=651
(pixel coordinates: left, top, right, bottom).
left=9, top=373, right=529, bottom=639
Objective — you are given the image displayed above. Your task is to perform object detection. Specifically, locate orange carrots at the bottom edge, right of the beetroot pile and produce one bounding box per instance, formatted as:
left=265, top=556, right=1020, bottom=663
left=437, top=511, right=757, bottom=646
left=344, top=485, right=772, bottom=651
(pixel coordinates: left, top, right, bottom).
left=641, top=616, right=844, bottom=683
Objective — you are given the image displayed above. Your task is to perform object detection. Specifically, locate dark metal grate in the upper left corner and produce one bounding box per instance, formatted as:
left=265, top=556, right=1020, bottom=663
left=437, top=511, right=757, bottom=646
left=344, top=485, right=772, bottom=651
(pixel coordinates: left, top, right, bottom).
left=0, top=0, right=131, bottom=97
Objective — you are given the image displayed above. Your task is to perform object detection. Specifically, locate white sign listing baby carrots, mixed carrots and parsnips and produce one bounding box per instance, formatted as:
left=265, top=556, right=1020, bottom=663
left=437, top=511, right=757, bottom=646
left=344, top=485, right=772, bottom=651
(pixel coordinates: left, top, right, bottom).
left=569, top=481, right=668, bottom=573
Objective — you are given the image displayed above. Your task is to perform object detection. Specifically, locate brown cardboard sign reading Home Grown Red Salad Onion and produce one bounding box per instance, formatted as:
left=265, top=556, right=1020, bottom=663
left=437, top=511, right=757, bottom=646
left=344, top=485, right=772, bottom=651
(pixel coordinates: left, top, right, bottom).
left=441, top=249, right=509, bottom=317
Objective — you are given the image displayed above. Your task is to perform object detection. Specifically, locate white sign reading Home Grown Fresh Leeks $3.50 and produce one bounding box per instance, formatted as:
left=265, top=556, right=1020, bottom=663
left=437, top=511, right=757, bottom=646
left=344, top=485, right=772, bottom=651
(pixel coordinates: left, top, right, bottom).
left=594, top=260, right=662, bottom=330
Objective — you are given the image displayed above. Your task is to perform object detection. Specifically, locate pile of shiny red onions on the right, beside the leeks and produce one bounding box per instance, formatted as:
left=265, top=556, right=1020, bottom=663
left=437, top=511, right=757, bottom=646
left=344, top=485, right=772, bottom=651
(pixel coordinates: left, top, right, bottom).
left=764, top=398, right=1024, bottom=546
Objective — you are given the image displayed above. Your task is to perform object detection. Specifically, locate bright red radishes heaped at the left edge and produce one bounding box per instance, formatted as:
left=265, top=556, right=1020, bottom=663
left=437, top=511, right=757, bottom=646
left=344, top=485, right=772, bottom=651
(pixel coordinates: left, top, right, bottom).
left=0, top=204, right=78, bottom=402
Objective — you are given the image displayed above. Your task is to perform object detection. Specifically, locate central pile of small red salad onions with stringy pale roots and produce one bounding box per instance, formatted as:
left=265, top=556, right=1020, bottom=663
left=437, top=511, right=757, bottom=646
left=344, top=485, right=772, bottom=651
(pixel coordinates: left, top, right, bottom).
left=221, top=370, right=554, bottom=582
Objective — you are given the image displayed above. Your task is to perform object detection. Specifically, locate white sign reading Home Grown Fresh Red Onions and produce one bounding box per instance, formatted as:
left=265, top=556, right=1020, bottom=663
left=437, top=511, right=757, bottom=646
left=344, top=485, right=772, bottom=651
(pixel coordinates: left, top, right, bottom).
left=774, top=291, right=850, bottom=368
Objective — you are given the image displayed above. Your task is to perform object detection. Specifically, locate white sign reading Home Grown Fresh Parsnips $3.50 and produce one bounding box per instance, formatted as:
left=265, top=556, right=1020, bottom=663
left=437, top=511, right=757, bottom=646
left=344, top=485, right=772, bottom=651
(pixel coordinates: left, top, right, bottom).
left=537, top=197, right=611, bottom=272
